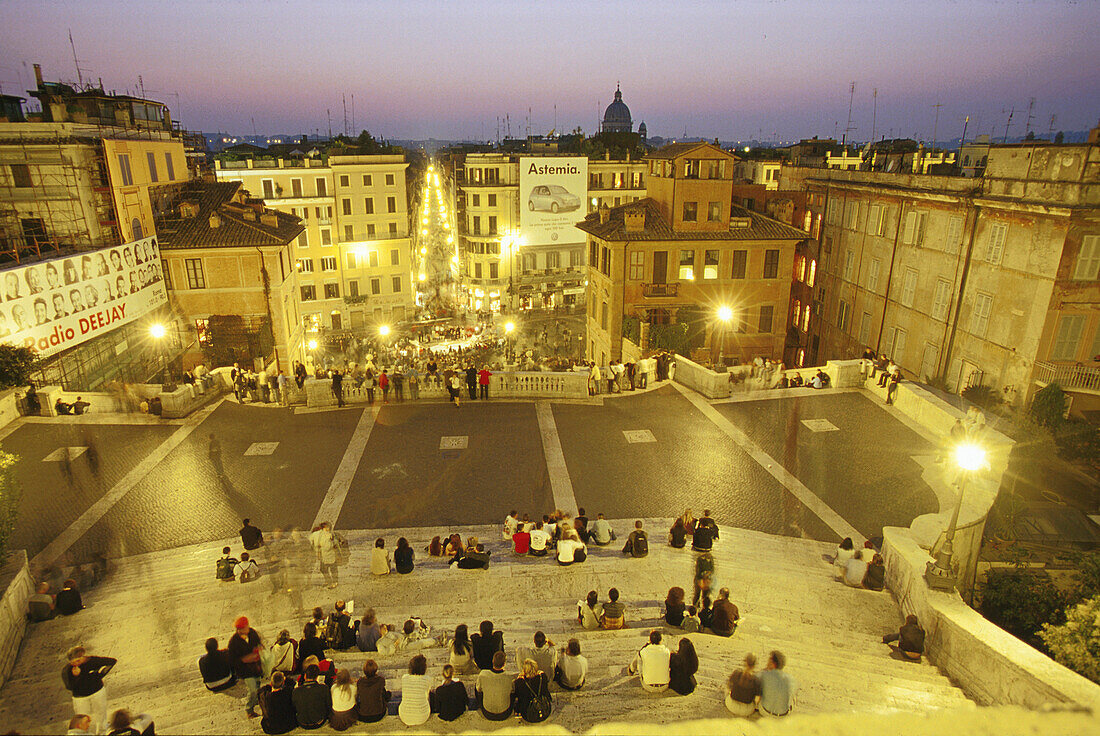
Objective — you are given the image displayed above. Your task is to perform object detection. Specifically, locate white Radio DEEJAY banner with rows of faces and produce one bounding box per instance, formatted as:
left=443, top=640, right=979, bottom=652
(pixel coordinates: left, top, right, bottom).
left=0, top=237, right=168, bottom=358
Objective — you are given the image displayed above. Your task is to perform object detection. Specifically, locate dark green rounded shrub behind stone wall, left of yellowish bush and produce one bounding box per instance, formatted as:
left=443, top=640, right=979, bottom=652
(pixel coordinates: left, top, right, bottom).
left=978, top=565, right=1065, bottom=648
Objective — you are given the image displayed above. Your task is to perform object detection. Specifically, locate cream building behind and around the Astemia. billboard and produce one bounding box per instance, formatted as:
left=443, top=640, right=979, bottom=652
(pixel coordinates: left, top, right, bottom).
left=449, top=152, right=646, bottom=310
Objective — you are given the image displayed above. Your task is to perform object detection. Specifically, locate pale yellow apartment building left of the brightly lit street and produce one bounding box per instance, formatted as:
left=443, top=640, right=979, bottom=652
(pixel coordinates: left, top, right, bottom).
left=215, top=150, right=416, bottom=339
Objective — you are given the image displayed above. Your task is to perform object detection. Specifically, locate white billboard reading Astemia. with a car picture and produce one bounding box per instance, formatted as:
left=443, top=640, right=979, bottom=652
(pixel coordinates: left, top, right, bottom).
left=519, top=156, right=589, bottom=245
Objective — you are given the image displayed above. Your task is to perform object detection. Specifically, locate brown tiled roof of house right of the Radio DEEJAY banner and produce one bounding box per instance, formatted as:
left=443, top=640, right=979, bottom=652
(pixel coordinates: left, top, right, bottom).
left=155, top=182, right=305, bottom=250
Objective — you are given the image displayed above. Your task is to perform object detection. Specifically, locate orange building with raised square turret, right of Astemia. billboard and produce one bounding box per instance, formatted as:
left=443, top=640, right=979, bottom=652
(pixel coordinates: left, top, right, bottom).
left=578, top=143, right=806, bottom=363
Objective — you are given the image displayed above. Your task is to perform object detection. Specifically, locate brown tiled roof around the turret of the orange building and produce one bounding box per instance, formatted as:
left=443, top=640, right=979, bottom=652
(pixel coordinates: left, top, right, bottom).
left=576, top=197, right=810, bottom=241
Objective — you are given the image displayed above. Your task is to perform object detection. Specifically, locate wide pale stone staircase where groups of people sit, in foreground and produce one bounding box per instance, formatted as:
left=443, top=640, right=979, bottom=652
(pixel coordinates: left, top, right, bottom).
left=0, top=519, right=972, bottom=734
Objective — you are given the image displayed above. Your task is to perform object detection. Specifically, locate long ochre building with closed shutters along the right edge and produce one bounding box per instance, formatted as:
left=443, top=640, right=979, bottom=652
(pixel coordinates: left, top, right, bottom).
left=791, top=134, right=1100, bottom=411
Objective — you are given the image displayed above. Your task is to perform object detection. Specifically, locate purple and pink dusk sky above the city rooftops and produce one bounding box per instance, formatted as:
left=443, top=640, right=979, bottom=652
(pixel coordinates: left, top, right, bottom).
left=0, top=0, right=1100, bottom=140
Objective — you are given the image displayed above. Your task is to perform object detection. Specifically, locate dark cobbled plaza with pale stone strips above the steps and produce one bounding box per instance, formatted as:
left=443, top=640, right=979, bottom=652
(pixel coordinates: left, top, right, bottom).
left=0, top=384, right=937, bottom=565
